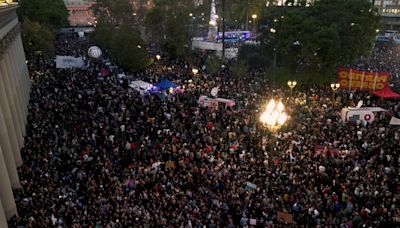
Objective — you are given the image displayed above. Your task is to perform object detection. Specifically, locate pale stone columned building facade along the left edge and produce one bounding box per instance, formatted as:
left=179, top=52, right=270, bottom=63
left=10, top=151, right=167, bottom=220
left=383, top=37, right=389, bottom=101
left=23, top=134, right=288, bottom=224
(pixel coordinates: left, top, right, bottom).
left=0, top=0, right=30, bottom=225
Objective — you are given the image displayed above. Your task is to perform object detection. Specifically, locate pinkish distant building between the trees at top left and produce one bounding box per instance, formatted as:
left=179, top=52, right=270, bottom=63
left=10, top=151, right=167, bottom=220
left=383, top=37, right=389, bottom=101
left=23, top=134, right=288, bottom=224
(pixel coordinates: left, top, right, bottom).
left=64, top=0, right=96, bottom=27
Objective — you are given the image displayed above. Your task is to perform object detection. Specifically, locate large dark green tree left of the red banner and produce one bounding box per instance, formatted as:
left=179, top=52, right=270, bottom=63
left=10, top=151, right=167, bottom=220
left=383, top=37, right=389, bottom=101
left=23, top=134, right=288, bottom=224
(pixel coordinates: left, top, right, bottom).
left=261, top=0, right=379, bottom=71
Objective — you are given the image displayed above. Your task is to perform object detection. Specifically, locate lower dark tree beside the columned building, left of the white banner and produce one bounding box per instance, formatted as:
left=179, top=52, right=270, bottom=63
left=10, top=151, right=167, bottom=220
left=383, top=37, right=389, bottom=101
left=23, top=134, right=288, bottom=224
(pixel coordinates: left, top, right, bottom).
left=21, top=20, right=54, bottom=59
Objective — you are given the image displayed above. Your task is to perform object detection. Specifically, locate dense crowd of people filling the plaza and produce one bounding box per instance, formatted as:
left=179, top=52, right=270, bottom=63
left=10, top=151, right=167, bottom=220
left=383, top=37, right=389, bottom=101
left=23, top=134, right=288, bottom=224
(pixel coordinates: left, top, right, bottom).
left=9, top=34, right=400, bottom=227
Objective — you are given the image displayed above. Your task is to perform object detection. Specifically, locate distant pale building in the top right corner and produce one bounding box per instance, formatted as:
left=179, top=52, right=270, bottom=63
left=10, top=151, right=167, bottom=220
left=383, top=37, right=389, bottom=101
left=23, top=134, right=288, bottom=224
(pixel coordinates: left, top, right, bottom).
left=371, top=0, right=400, bottom=31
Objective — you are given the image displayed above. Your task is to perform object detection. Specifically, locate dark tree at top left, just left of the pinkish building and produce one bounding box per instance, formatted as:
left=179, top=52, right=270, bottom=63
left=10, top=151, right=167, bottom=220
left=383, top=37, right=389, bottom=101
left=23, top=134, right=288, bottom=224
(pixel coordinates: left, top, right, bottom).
left=18, top=0, right=68, bottom=29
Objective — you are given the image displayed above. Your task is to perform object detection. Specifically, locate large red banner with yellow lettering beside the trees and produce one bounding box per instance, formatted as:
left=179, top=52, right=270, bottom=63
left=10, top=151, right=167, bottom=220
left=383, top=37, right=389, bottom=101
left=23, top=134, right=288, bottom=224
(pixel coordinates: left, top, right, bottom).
left=338, top=68, right=390, bottom=90
